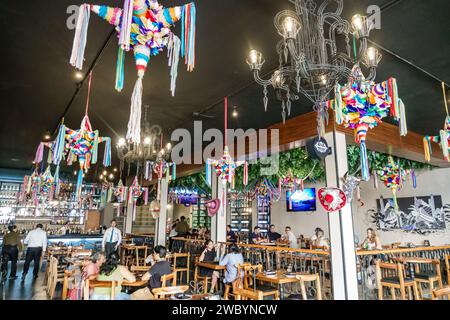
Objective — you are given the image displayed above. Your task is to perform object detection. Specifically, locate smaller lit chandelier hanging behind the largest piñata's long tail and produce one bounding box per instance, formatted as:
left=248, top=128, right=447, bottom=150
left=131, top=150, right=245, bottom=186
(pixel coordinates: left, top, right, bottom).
left=116, top=105, right=172, bottom=174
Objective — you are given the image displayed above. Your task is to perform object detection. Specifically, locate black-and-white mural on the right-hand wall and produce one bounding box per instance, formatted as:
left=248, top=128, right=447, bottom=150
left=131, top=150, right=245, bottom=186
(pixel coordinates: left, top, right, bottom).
left=369, top=195, right=450, bottom=235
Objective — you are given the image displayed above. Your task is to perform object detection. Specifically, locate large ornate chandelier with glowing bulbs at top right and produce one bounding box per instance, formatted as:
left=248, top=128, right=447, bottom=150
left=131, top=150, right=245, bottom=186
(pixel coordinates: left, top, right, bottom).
left=247, top=0, right=381, bottom=135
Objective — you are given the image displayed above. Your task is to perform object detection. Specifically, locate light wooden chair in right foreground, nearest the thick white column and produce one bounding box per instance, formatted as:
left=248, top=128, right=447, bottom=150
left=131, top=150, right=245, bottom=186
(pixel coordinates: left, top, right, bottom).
left=376, top=260, right=420, bottom=300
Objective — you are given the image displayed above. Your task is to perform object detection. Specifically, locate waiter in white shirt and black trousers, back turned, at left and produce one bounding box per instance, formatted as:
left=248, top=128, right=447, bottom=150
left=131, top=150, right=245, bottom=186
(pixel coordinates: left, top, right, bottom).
left=22, top=223, right=47, bottom=281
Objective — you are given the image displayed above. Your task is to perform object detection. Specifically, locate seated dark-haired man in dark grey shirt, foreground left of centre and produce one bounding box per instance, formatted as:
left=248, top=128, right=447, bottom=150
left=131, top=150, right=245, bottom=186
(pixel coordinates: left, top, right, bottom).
left=131, top=246, right=172, bottom=300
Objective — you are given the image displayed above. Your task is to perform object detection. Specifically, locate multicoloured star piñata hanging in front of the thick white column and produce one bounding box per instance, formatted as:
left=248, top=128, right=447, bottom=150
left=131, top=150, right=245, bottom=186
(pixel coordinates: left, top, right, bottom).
left=332, top=65, right=407, bottom=181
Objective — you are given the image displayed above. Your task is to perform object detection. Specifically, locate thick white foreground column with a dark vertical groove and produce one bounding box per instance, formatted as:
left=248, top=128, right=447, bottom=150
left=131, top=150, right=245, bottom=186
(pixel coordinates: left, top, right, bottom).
left=325, top=132, right=358, bottom=300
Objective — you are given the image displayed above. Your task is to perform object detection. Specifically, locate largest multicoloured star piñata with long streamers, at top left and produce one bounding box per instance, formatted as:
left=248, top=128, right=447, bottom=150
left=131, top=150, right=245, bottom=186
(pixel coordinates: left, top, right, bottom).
left=70, top=0, right=196, bottom=143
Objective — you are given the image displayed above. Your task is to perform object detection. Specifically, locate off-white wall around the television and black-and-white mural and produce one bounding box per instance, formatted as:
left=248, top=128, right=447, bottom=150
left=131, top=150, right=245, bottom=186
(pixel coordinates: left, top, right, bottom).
left=268, top=168, right=450, bottom=245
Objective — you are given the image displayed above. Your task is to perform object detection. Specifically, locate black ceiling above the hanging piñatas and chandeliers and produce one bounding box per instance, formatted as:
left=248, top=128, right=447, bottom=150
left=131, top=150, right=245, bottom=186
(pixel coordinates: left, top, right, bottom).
left=0, top=0, right=450, bottom=175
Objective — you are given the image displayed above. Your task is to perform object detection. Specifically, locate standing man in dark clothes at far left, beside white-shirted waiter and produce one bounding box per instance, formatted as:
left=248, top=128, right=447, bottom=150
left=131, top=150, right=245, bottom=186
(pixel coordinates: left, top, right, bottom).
left=1, top=225, right=22, bottom=279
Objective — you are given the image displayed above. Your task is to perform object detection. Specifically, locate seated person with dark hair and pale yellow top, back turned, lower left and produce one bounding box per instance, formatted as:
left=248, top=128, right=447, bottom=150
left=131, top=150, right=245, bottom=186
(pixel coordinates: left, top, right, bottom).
left=91, top=252, right=136, bottom=300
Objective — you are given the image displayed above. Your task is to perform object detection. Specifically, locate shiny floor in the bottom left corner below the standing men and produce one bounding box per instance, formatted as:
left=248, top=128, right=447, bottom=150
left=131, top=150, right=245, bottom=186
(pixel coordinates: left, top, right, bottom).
left=0, top=261, right=48, bottom=300
